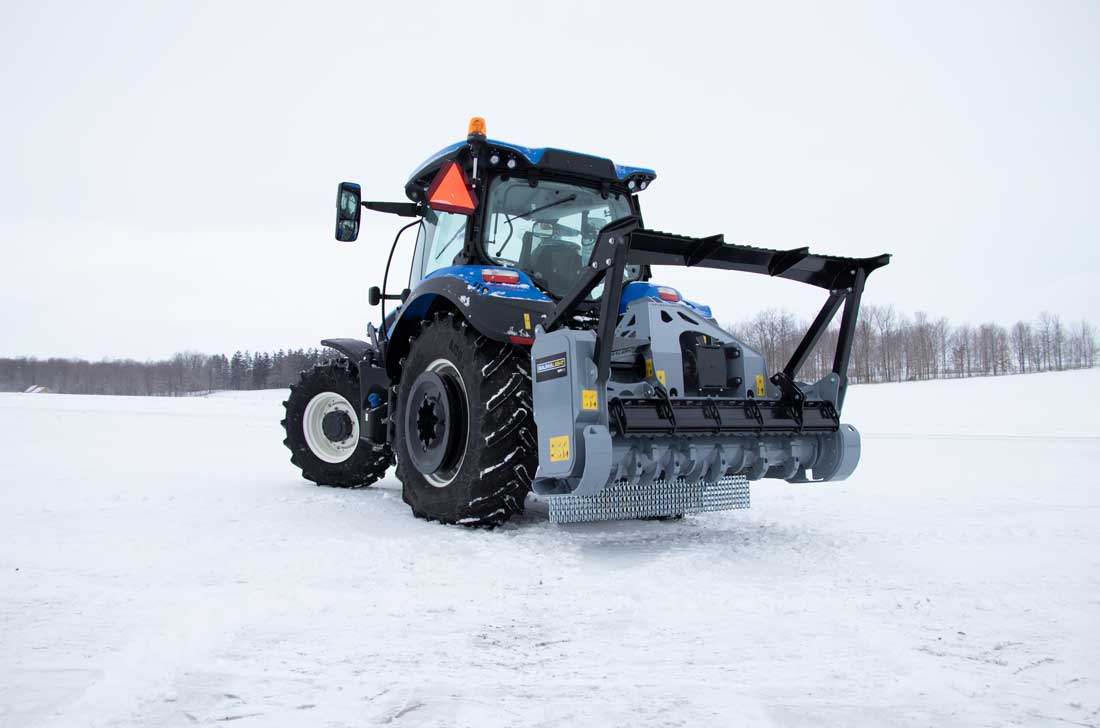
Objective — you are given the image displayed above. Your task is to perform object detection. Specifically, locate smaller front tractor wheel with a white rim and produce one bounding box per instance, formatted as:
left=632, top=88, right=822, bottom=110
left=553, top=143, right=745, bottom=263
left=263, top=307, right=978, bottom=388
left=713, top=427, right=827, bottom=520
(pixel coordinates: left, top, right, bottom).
left=283, top=359, right=393, bottom=488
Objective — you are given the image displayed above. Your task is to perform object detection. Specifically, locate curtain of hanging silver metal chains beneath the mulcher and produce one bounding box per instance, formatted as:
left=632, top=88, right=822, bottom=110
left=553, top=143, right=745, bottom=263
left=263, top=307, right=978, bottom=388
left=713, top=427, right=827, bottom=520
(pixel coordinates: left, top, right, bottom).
left=548, top=475, right=749, bottom=523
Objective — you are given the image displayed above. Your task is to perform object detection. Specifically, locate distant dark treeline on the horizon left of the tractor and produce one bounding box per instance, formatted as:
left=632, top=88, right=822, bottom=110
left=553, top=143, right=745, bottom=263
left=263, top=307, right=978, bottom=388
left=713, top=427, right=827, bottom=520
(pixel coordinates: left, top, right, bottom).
left=0, top=349, right=338, bottom=397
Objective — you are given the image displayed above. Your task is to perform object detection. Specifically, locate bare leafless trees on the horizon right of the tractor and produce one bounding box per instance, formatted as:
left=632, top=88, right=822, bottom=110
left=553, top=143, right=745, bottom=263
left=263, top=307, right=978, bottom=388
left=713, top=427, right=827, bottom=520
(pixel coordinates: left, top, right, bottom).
left=726, top=305, right=1098, bottom=383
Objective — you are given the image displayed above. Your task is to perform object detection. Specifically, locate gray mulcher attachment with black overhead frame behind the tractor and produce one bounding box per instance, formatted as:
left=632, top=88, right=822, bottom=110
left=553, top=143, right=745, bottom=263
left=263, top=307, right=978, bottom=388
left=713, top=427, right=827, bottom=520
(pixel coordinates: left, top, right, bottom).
left=531, top=219, right=889, bottom=520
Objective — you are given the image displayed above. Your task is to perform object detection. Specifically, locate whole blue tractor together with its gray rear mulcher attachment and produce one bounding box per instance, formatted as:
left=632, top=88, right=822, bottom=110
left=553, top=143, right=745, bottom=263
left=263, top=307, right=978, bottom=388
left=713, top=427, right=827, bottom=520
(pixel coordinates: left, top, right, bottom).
left=283, top=118, right=890, bottom=526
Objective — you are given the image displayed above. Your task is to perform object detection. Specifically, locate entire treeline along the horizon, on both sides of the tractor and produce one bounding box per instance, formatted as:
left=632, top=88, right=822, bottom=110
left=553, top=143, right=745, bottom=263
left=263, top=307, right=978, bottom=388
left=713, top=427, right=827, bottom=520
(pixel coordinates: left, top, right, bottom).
left=0, top=305, right=1098, bottom=397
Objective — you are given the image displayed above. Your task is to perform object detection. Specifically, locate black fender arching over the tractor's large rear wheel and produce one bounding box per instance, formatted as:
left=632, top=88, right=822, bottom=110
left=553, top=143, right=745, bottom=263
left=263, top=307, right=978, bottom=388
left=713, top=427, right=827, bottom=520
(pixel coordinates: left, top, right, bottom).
left=386, top=275, right=554, bottom=380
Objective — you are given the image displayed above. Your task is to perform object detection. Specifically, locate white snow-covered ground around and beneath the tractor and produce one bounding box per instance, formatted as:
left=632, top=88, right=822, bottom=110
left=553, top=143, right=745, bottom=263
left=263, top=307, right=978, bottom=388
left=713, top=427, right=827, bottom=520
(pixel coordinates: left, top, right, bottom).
left=0, top=371, right=1100, bottom=728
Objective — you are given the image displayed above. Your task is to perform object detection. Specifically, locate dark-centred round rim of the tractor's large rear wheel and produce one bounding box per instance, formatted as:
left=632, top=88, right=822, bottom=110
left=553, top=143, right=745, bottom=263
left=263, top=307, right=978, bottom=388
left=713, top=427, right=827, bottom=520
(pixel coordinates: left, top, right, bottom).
left=404, top=359, right=470, bottom=488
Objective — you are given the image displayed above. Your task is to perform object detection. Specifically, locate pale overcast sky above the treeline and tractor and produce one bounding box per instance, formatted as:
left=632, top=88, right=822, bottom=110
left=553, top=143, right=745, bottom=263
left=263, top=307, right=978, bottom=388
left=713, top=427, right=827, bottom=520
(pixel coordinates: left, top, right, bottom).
left=0, top=1, right=1100, bottom=359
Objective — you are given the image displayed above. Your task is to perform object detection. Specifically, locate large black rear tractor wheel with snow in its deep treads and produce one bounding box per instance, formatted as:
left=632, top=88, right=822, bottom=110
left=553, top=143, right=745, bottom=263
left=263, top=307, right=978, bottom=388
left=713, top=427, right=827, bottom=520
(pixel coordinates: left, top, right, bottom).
left=394, top=312, right=538, bottom=526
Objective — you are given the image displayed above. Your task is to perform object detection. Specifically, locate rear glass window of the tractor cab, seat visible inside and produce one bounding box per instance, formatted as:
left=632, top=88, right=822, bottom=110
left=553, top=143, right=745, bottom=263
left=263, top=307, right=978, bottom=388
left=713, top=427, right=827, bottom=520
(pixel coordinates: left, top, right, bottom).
left=485, top=178, right=640, bottom=298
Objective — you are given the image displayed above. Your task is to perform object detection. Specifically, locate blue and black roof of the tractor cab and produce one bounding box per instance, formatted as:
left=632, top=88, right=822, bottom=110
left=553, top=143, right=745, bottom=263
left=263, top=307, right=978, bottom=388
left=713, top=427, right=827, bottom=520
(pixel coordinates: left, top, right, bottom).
left=405, top=139, right=657, bottom=199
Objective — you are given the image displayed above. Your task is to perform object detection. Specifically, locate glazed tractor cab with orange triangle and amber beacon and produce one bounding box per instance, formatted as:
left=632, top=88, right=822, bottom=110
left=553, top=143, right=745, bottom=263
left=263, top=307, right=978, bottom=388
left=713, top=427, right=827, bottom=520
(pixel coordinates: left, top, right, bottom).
left=405, top=123, right=657, bottom=300
